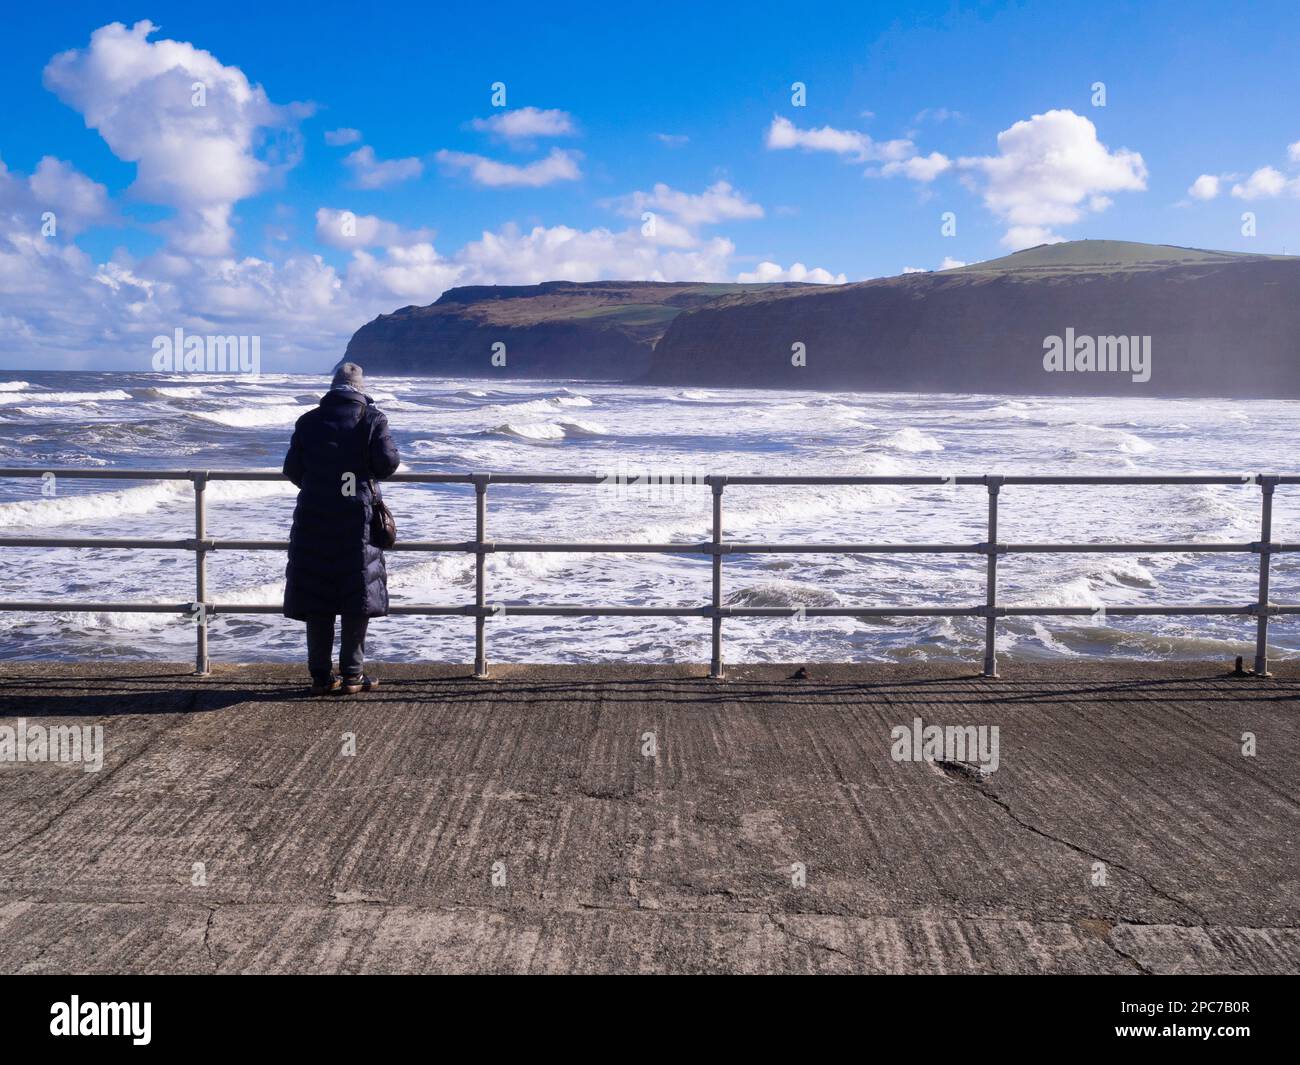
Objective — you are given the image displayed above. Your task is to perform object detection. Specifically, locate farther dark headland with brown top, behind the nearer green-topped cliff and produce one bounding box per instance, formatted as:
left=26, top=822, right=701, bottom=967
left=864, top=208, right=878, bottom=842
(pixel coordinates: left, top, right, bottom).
left=343, top=281, right=802, bottom=381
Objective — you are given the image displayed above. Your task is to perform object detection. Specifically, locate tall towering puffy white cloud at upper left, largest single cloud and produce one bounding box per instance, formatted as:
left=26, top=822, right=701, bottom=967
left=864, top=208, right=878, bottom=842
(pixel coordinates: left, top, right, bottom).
left=44, top=20, right=309, bottom=255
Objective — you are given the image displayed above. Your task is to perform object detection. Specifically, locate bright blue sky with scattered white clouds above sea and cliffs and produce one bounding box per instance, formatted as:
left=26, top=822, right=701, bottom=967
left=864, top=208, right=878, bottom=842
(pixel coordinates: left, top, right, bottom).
left=0, top=0, right=1300, bottom=369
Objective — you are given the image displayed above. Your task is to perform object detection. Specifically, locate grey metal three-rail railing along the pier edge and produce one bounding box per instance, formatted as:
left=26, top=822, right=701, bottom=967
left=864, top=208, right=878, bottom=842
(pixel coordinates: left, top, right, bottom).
left=0, top=468, right=1300, bottom=679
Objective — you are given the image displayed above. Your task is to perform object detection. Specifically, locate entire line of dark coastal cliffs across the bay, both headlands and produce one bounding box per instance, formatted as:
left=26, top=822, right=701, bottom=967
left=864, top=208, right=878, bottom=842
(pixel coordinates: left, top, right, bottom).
left=345, top=241, right=1300, bottom=398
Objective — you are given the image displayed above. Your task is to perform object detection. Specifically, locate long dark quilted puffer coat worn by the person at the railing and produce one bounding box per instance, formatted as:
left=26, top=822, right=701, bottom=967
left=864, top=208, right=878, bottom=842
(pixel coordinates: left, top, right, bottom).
left=285, top=390, right=399, bottom=620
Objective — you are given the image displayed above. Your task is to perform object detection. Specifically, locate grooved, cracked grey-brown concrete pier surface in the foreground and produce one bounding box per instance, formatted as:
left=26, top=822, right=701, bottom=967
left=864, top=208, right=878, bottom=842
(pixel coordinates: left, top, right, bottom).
left=0, top=662, right=1300, bottom=974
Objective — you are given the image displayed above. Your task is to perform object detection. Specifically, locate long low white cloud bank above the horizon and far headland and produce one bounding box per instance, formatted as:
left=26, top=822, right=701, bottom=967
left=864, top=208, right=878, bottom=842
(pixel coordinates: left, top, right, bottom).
left=0, top=208, right=754, bottom=369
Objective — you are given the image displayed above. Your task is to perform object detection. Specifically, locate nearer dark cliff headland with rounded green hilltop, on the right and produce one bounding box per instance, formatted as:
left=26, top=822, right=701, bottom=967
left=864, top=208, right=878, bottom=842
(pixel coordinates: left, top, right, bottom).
left=646, top=242, right=1300, bottom=398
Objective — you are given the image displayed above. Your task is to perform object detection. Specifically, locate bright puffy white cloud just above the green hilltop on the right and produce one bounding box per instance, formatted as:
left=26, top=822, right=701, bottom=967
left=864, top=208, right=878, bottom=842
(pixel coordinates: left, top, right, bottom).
left=958, top=111, right=1147, bottom=248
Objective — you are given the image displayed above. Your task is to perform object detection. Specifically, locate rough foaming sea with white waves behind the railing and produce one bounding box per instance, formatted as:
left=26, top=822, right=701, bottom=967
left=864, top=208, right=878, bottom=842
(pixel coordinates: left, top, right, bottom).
left=0, top=371, right=1300, bottom=664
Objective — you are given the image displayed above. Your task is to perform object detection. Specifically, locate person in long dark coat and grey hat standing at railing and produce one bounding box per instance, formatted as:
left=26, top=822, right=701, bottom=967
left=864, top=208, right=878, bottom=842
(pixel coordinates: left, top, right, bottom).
left=285, top=363, right=400, bottom=696
